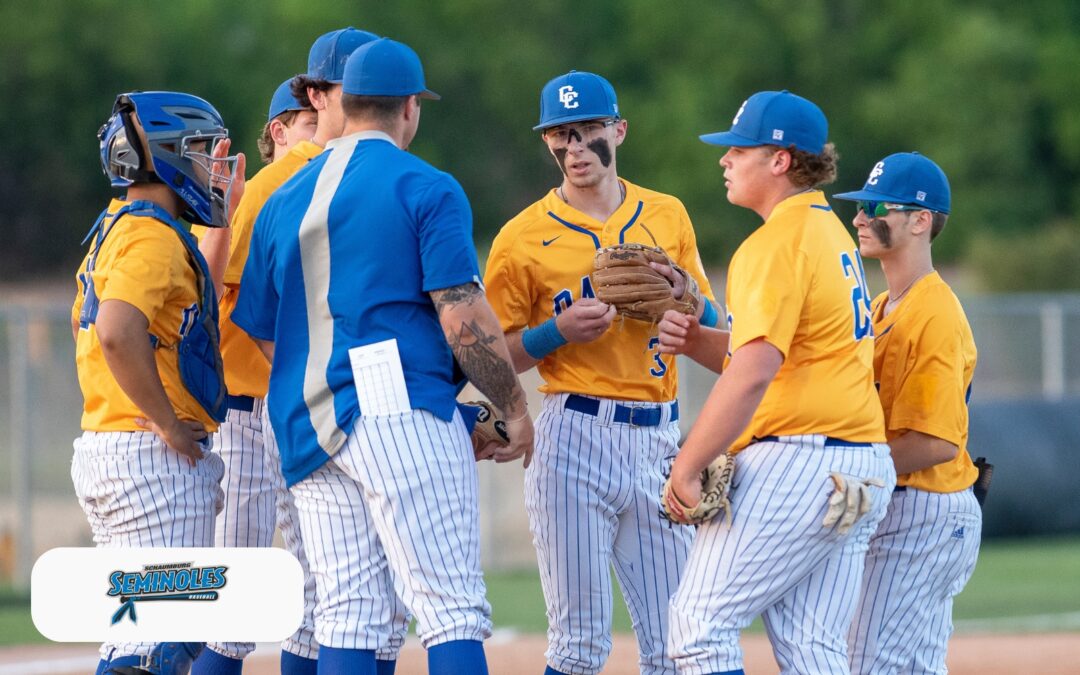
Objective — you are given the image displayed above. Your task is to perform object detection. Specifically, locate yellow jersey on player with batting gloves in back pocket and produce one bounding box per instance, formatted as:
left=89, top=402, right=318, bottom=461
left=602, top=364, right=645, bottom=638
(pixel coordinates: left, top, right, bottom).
left=726, top=191, right=885, bottom=451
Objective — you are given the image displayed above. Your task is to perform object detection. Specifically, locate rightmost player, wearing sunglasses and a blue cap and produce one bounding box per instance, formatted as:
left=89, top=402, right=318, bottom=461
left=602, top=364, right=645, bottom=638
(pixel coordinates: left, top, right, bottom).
left=836, top=152, right=983, bottom=673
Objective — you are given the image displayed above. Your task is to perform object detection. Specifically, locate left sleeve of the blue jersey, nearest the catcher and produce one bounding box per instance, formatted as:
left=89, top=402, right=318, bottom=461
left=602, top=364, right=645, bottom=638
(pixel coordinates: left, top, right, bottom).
left=232, top=207, right=278, bottom=342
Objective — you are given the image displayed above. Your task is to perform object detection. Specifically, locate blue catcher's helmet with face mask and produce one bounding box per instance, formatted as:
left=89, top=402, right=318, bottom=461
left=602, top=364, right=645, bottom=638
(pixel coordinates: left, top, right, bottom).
left=97, top=92, right=237, bottom=227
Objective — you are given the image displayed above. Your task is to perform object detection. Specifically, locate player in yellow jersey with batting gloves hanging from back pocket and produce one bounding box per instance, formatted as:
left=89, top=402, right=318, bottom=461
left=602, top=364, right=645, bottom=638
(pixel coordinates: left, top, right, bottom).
left=670, top=91, right=895, bottom=673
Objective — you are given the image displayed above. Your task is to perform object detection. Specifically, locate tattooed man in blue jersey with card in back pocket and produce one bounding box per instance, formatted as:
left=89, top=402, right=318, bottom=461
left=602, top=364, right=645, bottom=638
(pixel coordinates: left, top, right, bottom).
left=233, top=39, right=532, bottom=674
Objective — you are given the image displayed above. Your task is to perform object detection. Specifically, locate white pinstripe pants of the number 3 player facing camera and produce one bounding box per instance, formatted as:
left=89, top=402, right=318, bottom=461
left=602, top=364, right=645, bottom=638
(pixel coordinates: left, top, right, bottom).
left=525, top=394, right=693, bottom=675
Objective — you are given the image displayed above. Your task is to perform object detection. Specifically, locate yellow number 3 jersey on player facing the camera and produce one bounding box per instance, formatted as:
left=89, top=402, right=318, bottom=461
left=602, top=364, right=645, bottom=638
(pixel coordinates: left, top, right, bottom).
left=484, top=180, right=713, bottom=402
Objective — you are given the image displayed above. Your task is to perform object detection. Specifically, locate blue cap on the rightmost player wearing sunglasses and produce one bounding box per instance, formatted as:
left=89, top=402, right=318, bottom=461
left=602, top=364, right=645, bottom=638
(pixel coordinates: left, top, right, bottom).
left=833, top=152, right=951, bottom=214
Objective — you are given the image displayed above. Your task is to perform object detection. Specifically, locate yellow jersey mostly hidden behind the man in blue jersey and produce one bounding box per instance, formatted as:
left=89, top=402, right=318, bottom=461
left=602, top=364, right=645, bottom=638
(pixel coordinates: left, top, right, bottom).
left=192, top=140, right=323, bottom=399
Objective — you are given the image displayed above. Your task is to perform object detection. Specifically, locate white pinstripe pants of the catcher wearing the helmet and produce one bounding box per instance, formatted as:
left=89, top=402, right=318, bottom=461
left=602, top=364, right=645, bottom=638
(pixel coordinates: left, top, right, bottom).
left=71, top=431, right=225, bottom=659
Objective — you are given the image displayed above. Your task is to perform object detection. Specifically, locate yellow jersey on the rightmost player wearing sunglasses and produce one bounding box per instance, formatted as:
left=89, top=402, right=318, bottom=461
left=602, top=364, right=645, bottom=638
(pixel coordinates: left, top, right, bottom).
left=873, top=272, right=978, bottom=492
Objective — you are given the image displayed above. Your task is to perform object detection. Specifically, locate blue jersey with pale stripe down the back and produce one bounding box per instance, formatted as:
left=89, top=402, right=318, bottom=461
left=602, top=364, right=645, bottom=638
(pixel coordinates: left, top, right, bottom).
left=232, top=132, right=480, bottom=485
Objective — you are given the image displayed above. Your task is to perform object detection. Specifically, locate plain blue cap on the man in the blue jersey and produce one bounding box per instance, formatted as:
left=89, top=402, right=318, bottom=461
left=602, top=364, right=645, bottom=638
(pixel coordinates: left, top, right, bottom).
left=341, top=38, right=442, bottom=100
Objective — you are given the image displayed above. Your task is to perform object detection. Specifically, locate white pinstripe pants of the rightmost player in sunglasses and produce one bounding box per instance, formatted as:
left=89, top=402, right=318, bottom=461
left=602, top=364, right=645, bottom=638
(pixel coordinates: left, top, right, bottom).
left=848, top=487, right=983, bottom=674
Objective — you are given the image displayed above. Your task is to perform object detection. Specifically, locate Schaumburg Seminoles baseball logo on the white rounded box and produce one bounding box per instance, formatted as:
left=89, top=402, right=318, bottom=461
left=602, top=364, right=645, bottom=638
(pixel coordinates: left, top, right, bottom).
left=108, top=563, right=229, bottom=623
